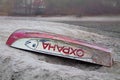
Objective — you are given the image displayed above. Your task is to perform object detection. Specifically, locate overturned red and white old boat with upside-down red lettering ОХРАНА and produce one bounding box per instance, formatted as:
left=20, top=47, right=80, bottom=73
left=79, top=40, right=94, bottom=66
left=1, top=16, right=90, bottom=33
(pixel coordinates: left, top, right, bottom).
left=6, top=29, right=113, bottom=66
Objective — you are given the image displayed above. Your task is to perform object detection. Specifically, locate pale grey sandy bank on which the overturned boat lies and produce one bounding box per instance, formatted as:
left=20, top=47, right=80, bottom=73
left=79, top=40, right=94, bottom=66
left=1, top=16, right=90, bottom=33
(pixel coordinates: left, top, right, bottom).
left=0, top=17, right=120, bottom=80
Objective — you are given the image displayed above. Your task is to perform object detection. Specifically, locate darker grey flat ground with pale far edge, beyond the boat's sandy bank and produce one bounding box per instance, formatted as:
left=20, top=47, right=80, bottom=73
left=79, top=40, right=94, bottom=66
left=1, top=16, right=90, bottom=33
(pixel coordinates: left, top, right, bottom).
left=1, top=16, right=120, bottom=38
